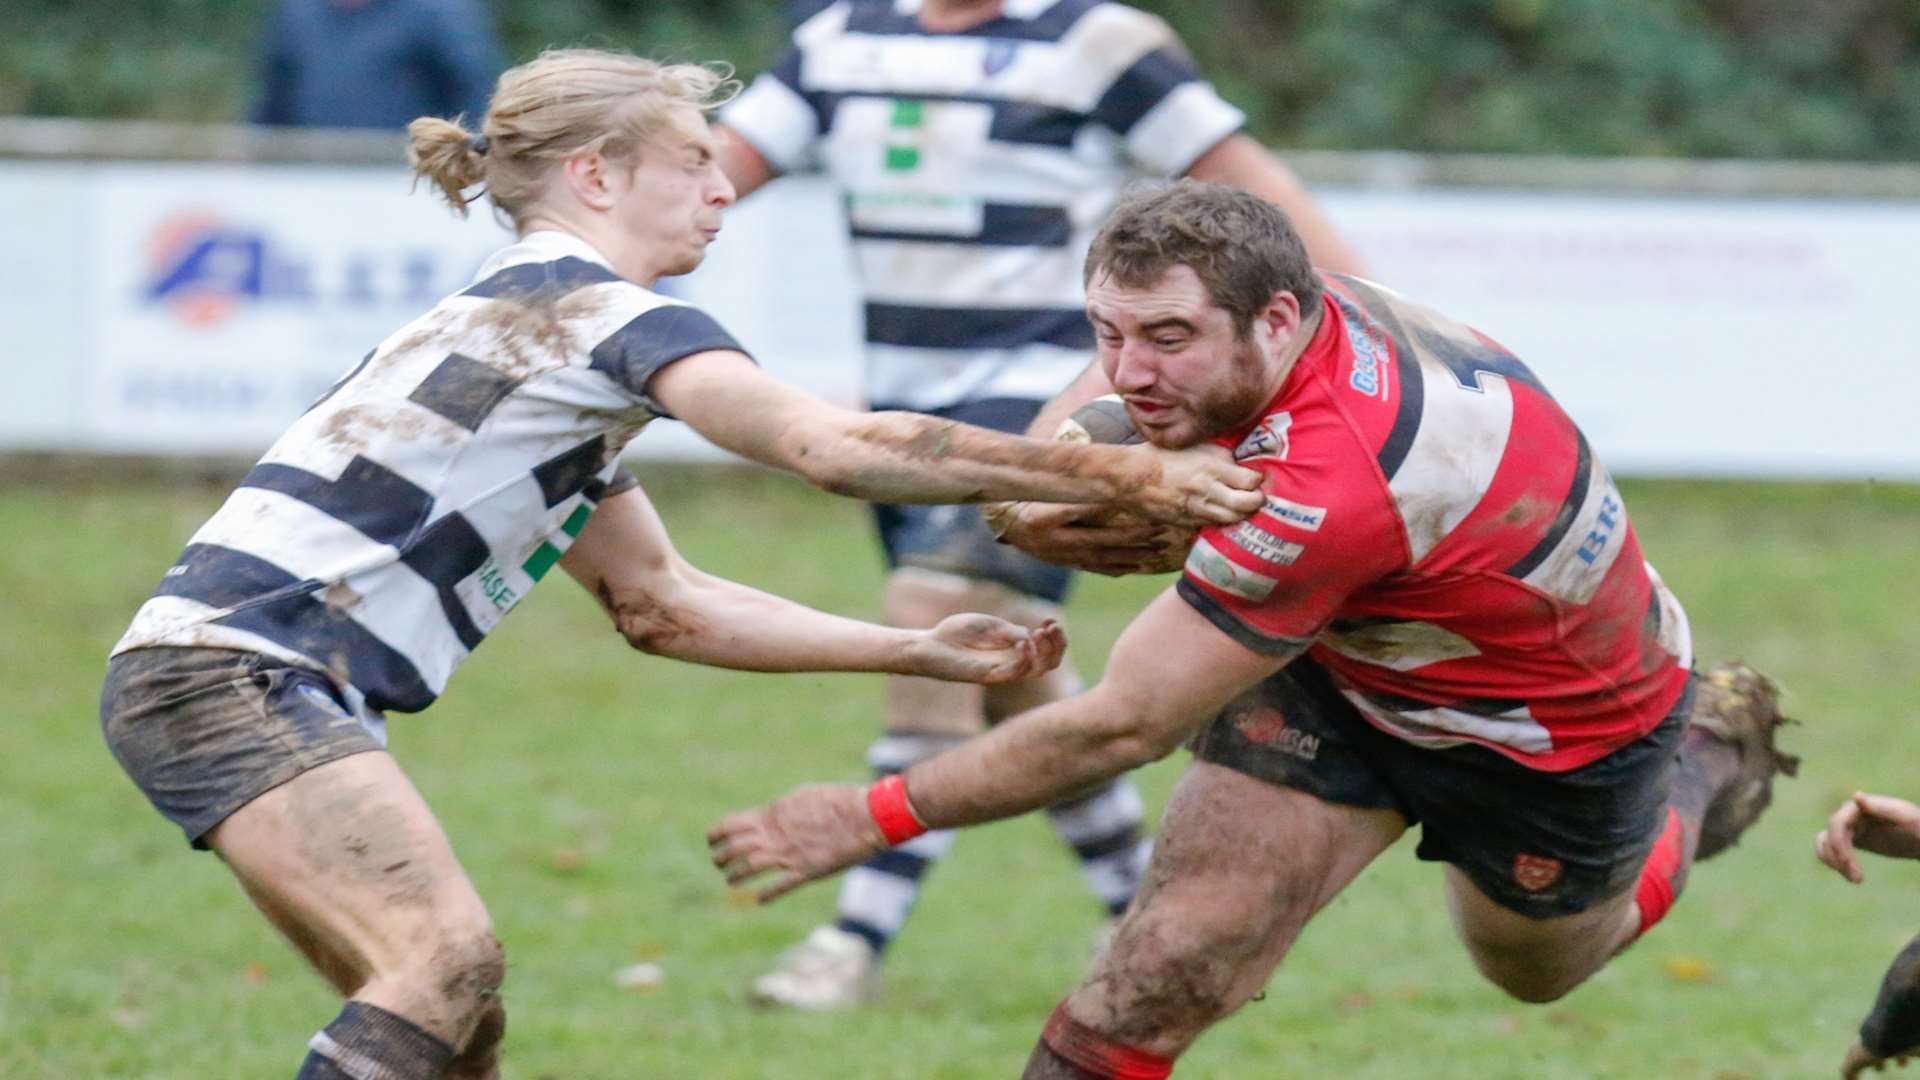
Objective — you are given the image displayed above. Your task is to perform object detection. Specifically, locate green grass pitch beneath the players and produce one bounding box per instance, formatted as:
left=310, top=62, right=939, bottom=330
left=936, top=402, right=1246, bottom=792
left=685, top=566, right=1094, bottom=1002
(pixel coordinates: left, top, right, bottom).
left=0, top=465, right=1920, bottom=1080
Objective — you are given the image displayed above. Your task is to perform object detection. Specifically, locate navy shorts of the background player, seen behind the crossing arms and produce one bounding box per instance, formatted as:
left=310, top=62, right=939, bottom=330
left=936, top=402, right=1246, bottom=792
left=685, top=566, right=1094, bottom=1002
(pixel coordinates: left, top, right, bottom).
left=874, top=398, right=1073, bottom=603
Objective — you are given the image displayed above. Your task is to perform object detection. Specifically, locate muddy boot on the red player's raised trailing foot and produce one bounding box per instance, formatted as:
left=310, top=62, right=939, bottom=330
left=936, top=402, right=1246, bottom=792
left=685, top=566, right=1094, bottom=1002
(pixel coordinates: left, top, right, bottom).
left=1693, top=661, right=1799, bottom=861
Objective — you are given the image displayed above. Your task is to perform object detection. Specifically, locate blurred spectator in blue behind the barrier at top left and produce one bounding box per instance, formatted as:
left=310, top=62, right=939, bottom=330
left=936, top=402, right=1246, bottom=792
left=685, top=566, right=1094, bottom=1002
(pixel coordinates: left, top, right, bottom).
left=253, top=0, right=501, bottom=131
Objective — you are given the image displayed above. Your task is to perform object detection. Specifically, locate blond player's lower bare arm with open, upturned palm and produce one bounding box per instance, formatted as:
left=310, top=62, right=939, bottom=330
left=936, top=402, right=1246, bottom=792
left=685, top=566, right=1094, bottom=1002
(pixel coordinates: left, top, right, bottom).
left=561, top=488, right=1066, bottom=682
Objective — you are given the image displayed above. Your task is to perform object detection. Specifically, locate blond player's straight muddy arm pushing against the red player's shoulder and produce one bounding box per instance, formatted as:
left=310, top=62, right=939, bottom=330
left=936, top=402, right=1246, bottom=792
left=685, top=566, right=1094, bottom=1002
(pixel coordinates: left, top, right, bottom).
left=647, top=350, right=1261, bottom=525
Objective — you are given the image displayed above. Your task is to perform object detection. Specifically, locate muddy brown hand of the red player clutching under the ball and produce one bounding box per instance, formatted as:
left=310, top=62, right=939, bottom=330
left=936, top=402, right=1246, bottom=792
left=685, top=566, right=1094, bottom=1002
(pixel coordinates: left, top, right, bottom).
left=989, top=502, right=1196, bottom=577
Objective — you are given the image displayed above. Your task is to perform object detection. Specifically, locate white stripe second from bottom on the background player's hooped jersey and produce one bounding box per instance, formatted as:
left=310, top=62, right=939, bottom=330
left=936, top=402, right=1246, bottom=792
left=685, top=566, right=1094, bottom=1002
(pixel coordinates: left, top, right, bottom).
left=854, top=240, right=1087, bottom=309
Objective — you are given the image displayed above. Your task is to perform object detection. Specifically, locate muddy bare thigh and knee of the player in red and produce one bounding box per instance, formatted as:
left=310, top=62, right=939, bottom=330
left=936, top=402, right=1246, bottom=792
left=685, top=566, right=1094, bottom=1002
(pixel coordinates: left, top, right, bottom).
left=1068, top=761, right=1405, bottom=1055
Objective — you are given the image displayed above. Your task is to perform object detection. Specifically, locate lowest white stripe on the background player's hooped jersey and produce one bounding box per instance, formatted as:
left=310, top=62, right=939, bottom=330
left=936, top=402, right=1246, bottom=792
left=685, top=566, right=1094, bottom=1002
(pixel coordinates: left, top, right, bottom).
left=866, top=344, right=1091, bottom=409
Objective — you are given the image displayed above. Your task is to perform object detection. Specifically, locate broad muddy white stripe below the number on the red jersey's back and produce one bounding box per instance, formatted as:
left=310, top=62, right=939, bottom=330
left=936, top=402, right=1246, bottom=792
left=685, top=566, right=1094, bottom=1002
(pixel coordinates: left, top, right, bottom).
left=1388, top=353, right=1513, bottom=563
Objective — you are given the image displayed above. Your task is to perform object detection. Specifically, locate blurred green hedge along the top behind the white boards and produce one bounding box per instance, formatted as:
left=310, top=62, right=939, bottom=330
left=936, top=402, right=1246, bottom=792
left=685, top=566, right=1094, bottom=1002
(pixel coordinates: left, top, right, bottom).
left=0, top=0, right=1920, bottom=161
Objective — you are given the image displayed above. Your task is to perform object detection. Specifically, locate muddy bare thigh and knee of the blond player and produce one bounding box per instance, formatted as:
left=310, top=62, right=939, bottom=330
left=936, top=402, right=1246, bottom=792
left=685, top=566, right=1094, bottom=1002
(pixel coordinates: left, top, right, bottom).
left=207, top=753, right=505, bottom=1047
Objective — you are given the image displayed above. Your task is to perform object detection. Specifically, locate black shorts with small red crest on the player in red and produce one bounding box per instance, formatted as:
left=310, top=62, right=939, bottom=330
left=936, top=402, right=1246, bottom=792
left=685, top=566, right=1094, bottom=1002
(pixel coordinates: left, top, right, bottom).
left=1194, top=657, right=1693, bottom=919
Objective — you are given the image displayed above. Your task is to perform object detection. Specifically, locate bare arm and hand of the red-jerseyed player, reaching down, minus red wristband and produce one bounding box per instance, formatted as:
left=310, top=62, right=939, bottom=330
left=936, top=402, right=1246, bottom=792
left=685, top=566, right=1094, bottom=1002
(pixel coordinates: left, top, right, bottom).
left=707, top=590, right=1292, bottom=901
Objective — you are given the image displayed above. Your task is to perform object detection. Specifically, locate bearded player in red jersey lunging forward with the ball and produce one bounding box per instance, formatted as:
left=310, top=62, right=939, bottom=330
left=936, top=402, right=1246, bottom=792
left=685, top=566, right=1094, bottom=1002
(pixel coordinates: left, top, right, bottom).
left=708, top=181, right=1795, bottom=1078
